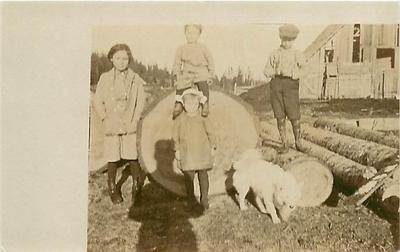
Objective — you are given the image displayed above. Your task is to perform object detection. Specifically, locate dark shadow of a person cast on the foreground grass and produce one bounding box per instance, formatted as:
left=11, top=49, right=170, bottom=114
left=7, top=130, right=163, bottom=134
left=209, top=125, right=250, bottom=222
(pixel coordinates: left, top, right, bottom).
left=129, top=182, right=202, bottom=252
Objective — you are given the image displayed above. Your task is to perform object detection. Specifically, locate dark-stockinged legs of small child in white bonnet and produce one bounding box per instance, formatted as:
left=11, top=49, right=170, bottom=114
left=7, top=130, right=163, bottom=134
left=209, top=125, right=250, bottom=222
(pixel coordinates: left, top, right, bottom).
left=183, top=170, right=209, bottom=209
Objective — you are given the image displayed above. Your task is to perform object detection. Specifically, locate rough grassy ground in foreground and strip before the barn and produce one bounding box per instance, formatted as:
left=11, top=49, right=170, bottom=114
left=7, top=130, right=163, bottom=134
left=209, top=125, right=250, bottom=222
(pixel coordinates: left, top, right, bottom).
left=88, top=85, right=399, bottom=252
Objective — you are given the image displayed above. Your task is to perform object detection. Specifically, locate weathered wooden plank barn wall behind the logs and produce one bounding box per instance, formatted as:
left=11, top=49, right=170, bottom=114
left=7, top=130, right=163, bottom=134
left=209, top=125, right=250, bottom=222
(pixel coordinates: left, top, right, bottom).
left=300, top=24, right=400, bottom=98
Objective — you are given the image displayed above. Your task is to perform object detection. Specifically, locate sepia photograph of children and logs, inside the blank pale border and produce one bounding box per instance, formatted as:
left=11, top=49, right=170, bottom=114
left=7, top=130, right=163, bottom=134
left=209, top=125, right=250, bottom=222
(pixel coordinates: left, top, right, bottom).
left=87, top=23, right=400, bottom=251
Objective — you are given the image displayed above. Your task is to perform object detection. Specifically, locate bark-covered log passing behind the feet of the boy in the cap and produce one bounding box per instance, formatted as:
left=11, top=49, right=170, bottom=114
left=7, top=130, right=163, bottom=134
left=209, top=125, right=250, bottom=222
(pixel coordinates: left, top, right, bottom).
left=261, top=122, right=377, bottom=191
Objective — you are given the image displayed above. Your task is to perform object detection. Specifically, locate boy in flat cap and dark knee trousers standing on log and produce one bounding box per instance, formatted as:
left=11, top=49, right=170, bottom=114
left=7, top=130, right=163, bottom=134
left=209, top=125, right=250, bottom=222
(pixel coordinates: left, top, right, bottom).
left=264, top=24, right=305, bottom=152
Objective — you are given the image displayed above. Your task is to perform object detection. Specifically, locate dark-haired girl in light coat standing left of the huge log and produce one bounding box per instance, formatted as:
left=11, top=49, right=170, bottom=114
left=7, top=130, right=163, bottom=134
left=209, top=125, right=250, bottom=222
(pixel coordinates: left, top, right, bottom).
left=94, top=44, right=145, bottom=204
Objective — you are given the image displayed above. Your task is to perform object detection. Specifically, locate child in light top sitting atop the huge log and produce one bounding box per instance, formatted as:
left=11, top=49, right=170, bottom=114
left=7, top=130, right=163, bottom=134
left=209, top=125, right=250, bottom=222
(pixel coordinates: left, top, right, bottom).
left=172, top=24, right=214, bottom=119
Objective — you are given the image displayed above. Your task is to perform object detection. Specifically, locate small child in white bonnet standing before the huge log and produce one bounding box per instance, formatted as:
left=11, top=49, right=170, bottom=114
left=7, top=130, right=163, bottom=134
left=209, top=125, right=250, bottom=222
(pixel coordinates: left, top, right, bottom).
left=173, top=89, right=216, bottom=209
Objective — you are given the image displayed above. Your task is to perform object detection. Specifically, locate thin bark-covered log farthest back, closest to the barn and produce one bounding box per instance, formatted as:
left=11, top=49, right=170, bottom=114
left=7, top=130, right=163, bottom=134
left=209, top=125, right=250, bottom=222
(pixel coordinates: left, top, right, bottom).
left=314, top=117, right=400, bottom=148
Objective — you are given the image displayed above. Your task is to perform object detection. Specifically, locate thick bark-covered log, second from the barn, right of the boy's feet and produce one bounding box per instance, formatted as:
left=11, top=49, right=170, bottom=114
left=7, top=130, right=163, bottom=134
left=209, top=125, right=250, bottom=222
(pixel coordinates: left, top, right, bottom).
left=302, top=124, right=399, bottom=170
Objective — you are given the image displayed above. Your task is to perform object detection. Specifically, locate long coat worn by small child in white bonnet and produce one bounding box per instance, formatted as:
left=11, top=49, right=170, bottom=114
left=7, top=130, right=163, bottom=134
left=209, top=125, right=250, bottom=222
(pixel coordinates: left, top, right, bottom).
left=173, top=113, right=217, bottom=171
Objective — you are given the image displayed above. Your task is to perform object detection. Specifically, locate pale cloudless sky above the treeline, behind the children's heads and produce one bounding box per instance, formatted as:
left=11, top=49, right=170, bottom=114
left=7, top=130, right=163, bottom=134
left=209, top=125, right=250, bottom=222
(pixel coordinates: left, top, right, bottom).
left=92, top=24, right=326, bottom=80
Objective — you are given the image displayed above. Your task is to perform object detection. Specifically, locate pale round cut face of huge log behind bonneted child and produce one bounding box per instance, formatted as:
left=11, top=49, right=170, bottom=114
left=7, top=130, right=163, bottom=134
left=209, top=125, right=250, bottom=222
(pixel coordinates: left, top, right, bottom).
left=137, top=89, right=259, bottom=195
